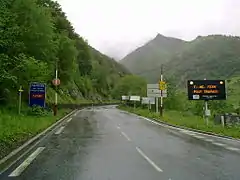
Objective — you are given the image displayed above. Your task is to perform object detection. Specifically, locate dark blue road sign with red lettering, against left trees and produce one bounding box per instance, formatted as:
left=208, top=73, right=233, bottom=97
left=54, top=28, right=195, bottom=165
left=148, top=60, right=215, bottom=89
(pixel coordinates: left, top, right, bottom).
left=29, top=82, right=46, bottom=107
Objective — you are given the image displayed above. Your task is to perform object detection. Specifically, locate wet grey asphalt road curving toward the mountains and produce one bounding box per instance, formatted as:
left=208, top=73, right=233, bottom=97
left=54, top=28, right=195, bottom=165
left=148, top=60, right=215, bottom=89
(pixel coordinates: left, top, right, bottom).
left=0, top=106, right=240, bottom=180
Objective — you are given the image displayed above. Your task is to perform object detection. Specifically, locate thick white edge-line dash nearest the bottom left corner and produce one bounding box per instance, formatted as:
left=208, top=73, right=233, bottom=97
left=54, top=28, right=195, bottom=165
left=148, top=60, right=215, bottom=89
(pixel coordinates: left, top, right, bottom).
left=9, top=147, right=45, bottom=177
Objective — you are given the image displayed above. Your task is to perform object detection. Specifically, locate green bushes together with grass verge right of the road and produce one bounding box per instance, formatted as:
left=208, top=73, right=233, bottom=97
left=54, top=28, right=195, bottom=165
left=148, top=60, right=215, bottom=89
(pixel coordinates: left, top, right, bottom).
left=118, top=74, right=240, bottom=138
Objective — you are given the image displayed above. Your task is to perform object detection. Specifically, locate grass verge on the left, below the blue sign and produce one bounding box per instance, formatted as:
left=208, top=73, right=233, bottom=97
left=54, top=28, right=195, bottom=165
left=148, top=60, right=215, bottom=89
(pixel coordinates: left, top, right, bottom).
left=0, top=109, right=70, bottom=159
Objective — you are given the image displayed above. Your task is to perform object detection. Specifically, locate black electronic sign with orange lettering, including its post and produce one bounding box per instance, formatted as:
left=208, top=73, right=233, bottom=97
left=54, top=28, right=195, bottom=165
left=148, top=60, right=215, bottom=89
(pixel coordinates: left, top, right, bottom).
left=187, top=79, right=226, bottom=125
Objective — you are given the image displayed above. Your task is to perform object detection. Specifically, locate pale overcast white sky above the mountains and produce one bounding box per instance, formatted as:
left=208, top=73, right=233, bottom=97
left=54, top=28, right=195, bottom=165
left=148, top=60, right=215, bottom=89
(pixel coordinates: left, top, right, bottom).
left=58, top=0, right=240, bottom=58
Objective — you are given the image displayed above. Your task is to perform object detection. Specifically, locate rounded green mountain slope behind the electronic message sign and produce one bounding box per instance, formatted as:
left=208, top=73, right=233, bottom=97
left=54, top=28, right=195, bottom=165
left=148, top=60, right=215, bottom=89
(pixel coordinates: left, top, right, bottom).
left=166, top=35, right=240, bottom=82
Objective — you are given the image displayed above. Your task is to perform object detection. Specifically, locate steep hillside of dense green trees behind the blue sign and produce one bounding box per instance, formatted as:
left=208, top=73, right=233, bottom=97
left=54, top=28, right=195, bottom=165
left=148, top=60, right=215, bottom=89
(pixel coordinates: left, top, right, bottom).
left=0, top=0, right=128, bottom=104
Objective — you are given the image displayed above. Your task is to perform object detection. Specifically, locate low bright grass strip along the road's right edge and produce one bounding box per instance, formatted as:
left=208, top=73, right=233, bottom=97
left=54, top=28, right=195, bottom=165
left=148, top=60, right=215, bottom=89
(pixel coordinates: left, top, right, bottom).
left=119, top=106, right=240, bottom=138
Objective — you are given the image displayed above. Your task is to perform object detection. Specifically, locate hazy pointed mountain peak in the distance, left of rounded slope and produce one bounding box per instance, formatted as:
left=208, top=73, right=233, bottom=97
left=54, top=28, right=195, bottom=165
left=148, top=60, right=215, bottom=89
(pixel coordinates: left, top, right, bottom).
left=120, top=34, right=186, bottom=79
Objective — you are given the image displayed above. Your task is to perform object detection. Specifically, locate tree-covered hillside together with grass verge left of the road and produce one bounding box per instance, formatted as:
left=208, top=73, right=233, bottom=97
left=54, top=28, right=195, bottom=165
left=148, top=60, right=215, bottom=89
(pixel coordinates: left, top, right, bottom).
left=0, top=0, right=129, bottom=158
